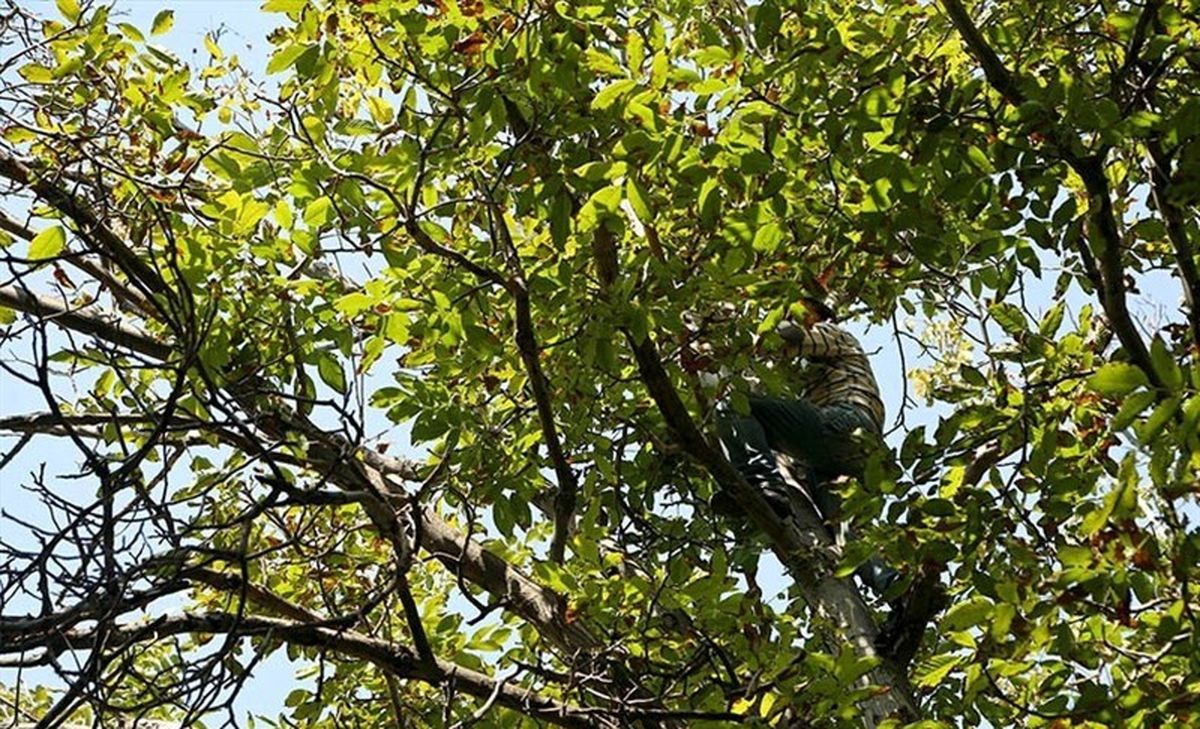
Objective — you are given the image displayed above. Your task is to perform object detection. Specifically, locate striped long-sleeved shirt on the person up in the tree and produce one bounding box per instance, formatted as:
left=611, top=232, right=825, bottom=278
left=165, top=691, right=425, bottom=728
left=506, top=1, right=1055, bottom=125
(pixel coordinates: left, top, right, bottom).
left=776, top=321, right=883, bottom=433
